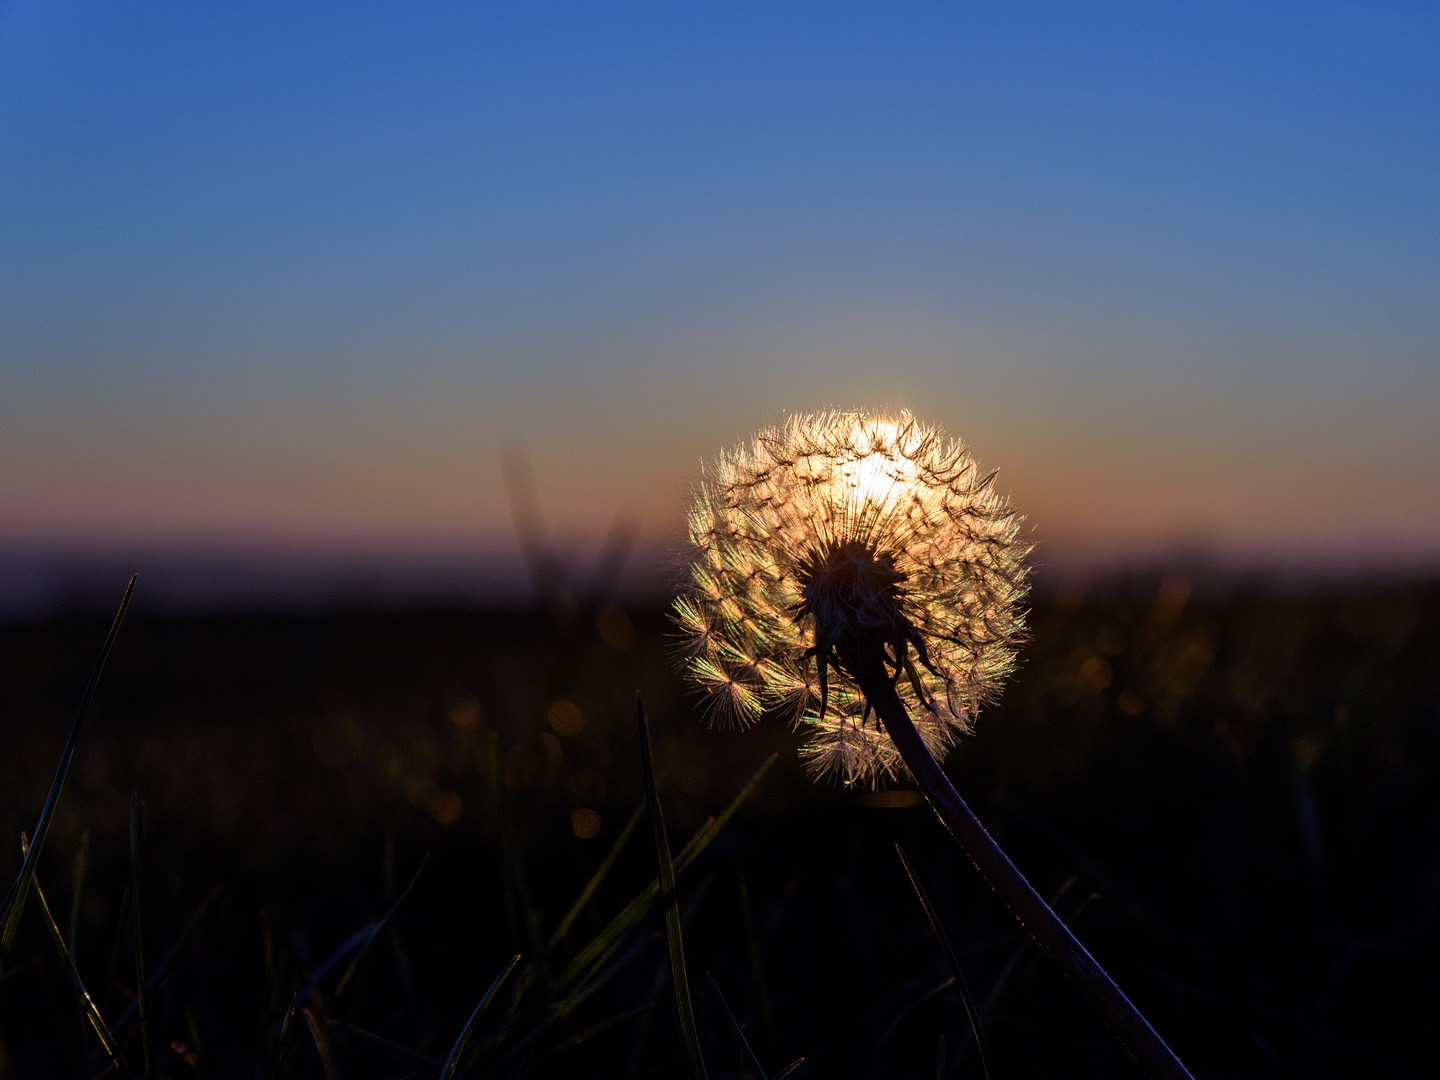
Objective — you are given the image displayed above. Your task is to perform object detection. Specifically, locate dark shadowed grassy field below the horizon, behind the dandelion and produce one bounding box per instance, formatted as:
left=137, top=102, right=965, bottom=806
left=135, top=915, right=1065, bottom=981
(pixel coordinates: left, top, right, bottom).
left=0, top=577, right=1440, bottom=1080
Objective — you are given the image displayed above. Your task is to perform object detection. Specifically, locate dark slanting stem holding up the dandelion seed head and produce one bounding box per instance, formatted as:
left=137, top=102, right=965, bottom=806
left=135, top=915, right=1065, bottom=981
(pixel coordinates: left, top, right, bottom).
left=855, top=668, right=1192, bottom=1080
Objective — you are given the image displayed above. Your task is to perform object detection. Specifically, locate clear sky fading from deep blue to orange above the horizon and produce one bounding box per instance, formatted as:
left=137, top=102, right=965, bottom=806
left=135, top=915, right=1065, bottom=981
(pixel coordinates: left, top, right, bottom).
left=0, top=0, right=1440, bottom=596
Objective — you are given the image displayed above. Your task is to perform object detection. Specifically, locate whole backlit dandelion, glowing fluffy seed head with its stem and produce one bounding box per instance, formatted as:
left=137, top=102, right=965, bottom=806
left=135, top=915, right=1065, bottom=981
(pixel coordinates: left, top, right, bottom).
left=674, top=412, right=1189, bottom=1079
